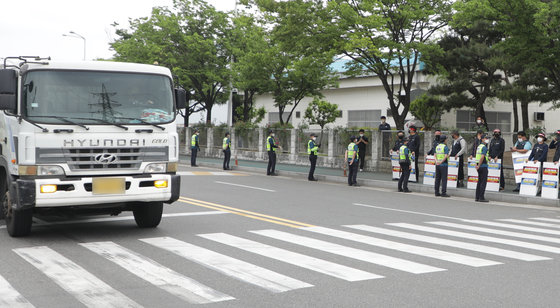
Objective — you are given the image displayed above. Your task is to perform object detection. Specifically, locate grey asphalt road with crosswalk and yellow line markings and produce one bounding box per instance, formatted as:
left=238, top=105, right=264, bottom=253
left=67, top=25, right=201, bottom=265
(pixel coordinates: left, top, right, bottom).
left=0, top=168, right=560, bottom=307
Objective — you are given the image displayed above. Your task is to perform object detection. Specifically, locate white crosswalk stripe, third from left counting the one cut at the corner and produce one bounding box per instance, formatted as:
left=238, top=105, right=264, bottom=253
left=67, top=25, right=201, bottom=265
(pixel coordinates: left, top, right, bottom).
left=80, top=242, right=235, bottom=304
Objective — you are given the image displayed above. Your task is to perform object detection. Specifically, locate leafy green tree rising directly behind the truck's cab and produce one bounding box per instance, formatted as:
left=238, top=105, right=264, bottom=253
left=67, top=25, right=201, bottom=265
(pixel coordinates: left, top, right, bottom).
left=111, top=0, right=231, bottom=124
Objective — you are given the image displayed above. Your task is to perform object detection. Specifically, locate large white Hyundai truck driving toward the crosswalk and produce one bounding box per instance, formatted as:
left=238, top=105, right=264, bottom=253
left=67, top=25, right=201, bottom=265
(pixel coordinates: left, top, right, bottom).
left=0, top=57, right=187, bottom=237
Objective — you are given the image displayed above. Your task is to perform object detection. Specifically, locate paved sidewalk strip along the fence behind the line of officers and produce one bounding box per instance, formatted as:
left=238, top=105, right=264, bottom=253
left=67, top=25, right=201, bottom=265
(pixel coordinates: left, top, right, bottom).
left=180, top=155, right=560, bottom=207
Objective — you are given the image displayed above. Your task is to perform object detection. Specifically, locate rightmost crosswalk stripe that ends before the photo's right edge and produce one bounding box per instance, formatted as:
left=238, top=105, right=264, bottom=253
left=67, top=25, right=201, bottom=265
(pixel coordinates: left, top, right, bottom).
left=345, top=225, right=550, bottom=261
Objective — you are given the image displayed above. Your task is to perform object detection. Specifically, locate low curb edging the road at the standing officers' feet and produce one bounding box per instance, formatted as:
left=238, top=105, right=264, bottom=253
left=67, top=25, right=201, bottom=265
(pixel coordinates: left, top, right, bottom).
left=185, top=162, right=560, bottom=207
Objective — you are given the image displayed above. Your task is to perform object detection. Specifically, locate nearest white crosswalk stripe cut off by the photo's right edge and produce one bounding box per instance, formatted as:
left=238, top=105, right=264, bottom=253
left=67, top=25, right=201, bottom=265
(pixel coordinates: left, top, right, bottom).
left=387, top=223, right=560, bottom=253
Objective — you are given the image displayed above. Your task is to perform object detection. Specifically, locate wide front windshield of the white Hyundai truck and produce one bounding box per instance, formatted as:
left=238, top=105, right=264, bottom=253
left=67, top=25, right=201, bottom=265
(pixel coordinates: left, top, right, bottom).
left=22, top=70, right=175, bottom=124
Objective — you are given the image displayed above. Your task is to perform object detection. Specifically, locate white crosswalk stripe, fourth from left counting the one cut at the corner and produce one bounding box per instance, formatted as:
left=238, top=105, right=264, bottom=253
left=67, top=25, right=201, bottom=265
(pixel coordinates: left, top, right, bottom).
left=141, top=237, right=313, bottom=293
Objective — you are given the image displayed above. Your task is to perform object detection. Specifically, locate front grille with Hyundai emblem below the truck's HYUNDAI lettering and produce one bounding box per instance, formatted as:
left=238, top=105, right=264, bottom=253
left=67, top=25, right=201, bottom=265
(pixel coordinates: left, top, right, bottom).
left=35, top=147, right=169, bottom=171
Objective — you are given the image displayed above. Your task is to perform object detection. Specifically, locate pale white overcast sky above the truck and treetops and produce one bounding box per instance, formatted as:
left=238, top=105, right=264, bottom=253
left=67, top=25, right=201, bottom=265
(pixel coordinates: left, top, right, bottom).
left=0, top=0, right=236, bottom=123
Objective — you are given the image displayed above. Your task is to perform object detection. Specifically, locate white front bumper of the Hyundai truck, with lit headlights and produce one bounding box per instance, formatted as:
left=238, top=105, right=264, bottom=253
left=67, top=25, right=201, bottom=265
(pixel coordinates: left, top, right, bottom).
left=16, top=174, right=180, bottom=209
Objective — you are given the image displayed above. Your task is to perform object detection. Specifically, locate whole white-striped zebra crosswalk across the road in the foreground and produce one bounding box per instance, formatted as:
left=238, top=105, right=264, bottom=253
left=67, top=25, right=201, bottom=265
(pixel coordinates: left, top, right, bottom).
left=0, top=217, right=560, bottom=307
